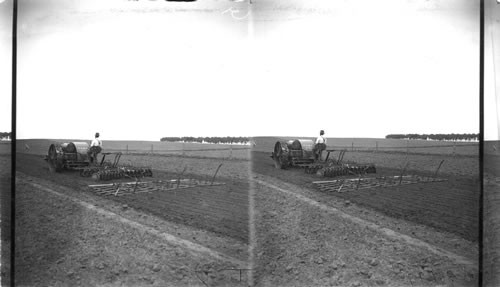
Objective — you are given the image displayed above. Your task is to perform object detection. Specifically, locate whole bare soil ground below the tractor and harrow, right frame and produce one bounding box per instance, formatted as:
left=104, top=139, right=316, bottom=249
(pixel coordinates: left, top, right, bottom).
left=252, top=152, right=479, bottom=286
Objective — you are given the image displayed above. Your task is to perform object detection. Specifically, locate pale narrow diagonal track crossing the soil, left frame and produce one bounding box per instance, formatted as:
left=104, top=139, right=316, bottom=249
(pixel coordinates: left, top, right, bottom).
left=21, top=182, right=247, bottom=268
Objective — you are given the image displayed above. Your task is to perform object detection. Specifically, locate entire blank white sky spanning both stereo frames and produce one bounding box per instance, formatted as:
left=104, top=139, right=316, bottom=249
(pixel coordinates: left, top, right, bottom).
left=2, top=0, right=494, bottom=140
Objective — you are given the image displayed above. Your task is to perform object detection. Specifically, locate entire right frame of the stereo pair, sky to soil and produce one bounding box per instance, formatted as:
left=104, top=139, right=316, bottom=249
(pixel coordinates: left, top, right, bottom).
left=248, top=0, right=480, bottom=286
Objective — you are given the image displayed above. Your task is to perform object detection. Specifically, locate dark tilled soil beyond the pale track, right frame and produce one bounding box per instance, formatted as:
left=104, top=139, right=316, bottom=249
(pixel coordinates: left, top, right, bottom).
left=253, top=152, right=480, bottom=242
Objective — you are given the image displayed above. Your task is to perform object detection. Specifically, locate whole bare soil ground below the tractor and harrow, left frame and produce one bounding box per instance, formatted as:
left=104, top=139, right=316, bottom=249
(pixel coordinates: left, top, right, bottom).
left=16, top=154, right=249, bottom=286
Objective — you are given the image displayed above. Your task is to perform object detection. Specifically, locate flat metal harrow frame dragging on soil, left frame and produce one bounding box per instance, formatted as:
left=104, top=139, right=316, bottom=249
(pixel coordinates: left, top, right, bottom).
left=89, top=178, right=225, bottom=196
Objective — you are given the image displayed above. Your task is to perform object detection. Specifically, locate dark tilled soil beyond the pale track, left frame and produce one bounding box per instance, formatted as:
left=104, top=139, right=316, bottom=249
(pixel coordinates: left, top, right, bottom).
left=17, top=153, right=249, bottom=242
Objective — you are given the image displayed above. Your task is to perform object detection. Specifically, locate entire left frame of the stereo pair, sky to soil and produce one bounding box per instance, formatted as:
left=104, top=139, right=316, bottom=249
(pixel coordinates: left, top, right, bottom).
left=14, top=0, right=251, bottom=286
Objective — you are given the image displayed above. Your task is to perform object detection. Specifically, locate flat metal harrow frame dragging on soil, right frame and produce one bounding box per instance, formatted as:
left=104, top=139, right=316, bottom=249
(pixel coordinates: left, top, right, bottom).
left=313, top=175, right=446, bottom=195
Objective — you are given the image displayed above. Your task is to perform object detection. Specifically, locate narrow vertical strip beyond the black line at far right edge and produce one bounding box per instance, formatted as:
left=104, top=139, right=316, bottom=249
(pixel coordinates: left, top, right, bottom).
left=483, top=0, right=500, bottom=286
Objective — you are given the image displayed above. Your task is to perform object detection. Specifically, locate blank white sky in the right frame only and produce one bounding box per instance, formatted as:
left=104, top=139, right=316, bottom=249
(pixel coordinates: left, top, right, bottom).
left=255, top=0, right=479, bottom=140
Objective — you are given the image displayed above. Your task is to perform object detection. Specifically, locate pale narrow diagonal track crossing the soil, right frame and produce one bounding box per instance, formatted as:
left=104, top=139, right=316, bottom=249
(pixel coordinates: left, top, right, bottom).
left=253, top=179, right=477, bottom=269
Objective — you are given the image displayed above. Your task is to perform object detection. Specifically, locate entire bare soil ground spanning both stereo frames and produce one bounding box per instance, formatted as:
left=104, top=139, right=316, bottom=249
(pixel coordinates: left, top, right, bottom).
left=10, top=145, right=484, bottom=286
